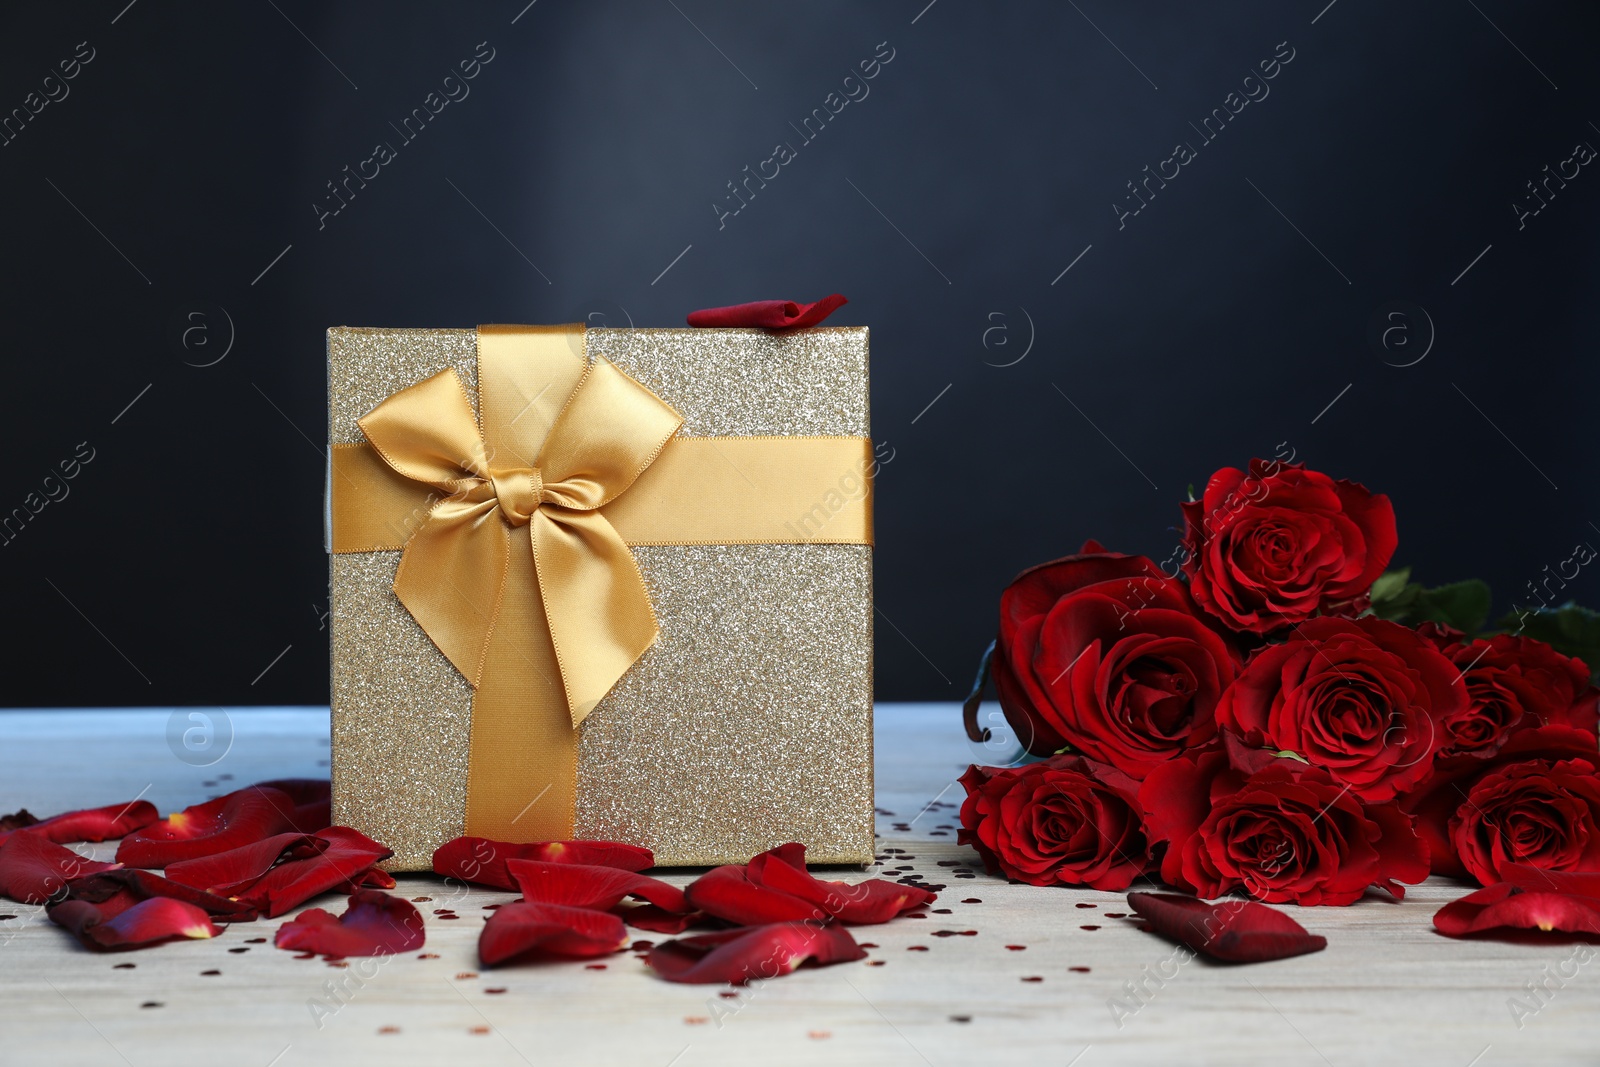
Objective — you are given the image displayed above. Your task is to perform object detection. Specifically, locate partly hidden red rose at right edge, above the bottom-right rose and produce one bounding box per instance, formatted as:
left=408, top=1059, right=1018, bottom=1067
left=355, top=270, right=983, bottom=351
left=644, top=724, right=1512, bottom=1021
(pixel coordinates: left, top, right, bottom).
left=1418, top=622, right=1600, bottom=757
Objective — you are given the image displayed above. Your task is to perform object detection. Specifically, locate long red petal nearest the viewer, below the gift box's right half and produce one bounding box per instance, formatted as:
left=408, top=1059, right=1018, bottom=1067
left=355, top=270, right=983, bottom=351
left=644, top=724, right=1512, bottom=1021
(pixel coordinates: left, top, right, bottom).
left=645, top=923, right=867, bottom=985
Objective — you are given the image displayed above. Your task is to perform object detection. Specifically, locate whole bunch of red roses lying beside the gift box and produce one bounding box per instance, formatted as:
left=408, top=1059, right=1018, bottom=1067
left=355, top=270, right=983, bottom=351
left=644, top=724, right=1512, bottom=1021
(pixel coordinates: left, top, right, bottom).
left=960, top=459, right=1600, bottom=907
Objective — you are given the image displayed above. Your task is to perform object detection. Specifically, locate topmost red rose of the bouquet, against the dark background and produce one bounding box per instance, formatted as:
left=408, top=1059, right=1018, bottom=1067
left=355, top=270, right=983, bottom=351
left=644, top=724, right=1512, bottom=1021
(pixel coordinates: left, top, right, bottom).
left=1182, top=459, right=1397, bottom=633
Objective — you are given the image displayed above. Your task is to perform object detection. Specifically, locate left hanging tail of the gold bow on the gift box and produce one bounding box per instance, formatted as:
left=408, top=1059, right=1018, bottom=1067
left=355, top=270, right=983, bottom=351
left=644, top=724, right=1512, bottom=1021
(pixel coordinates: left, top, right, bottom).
left=394, top=496, right=510, bottom=688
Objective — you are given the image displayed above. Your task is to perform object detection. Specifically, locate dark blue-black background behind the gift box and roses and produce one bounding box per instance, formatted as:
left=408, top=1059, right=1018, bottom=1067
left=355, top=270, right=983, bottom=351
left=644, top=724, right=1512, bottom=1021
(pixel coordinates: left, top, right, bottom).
left=0, top=0, right=1600, bottom=705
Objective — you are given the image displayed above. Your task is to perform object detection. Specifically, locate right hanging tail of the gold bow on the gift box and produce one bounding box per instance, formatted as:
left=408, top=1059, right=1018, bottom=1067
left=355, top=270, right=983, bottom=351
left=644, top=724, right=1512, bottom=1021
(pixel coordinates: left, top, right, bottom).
left=528, top=507, right=661, bottom=726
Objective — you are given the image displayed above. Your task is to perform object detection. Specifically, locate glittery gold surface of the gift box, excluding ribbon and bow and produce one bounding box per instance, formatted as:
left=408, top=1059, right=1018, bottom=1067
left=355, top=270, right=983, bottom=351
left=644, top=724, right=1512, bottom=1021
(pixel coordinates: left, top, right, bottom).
left=328, top=326, right=874, bottom=870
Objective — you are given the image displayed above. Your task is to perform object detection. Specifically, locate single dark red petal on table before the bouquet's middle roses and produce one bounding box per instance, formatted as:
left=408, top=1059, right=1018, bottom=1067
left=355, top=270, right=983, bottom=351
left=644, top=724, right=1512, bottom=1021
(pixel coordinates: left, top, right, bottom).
left=1128, top=893, right=1328, bottom=963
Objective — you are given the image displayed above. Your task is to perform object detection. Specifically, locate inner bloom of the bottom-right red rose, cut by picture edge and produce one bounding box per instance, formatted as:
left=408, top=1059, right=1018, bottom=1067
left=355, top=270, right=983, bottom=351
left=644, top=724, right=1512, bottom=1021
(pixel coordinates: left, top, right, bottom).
left=1450, top=760, right=1600, bottom=885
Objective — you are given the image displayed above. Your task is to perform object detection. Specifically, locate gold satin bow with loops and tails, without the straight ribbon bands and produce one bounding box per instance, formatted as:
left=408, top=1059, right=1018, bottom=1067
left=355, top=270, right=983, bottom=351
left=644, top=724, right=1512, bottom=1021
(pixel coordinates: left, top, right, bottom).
left=358, top=357, right=683, bottom=726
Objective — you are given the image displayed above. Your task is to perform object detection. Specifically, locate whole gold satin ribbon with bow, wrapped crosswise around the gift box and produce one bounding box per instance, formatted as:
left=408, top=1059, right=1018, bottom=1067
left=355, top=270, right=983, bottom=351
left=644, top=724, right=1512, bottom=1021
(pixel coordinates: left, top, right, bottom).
left=331, top=326, right=872, bottom=841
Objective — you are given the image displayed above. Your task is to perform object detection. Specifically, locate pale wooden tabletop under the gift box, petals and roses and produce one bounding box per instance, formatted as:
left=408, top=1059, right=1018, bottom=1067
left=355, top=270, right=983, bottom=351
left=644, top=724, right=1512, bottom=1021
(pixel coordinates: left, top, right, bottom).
left=0, top=704, right=1600, bottom=1067
